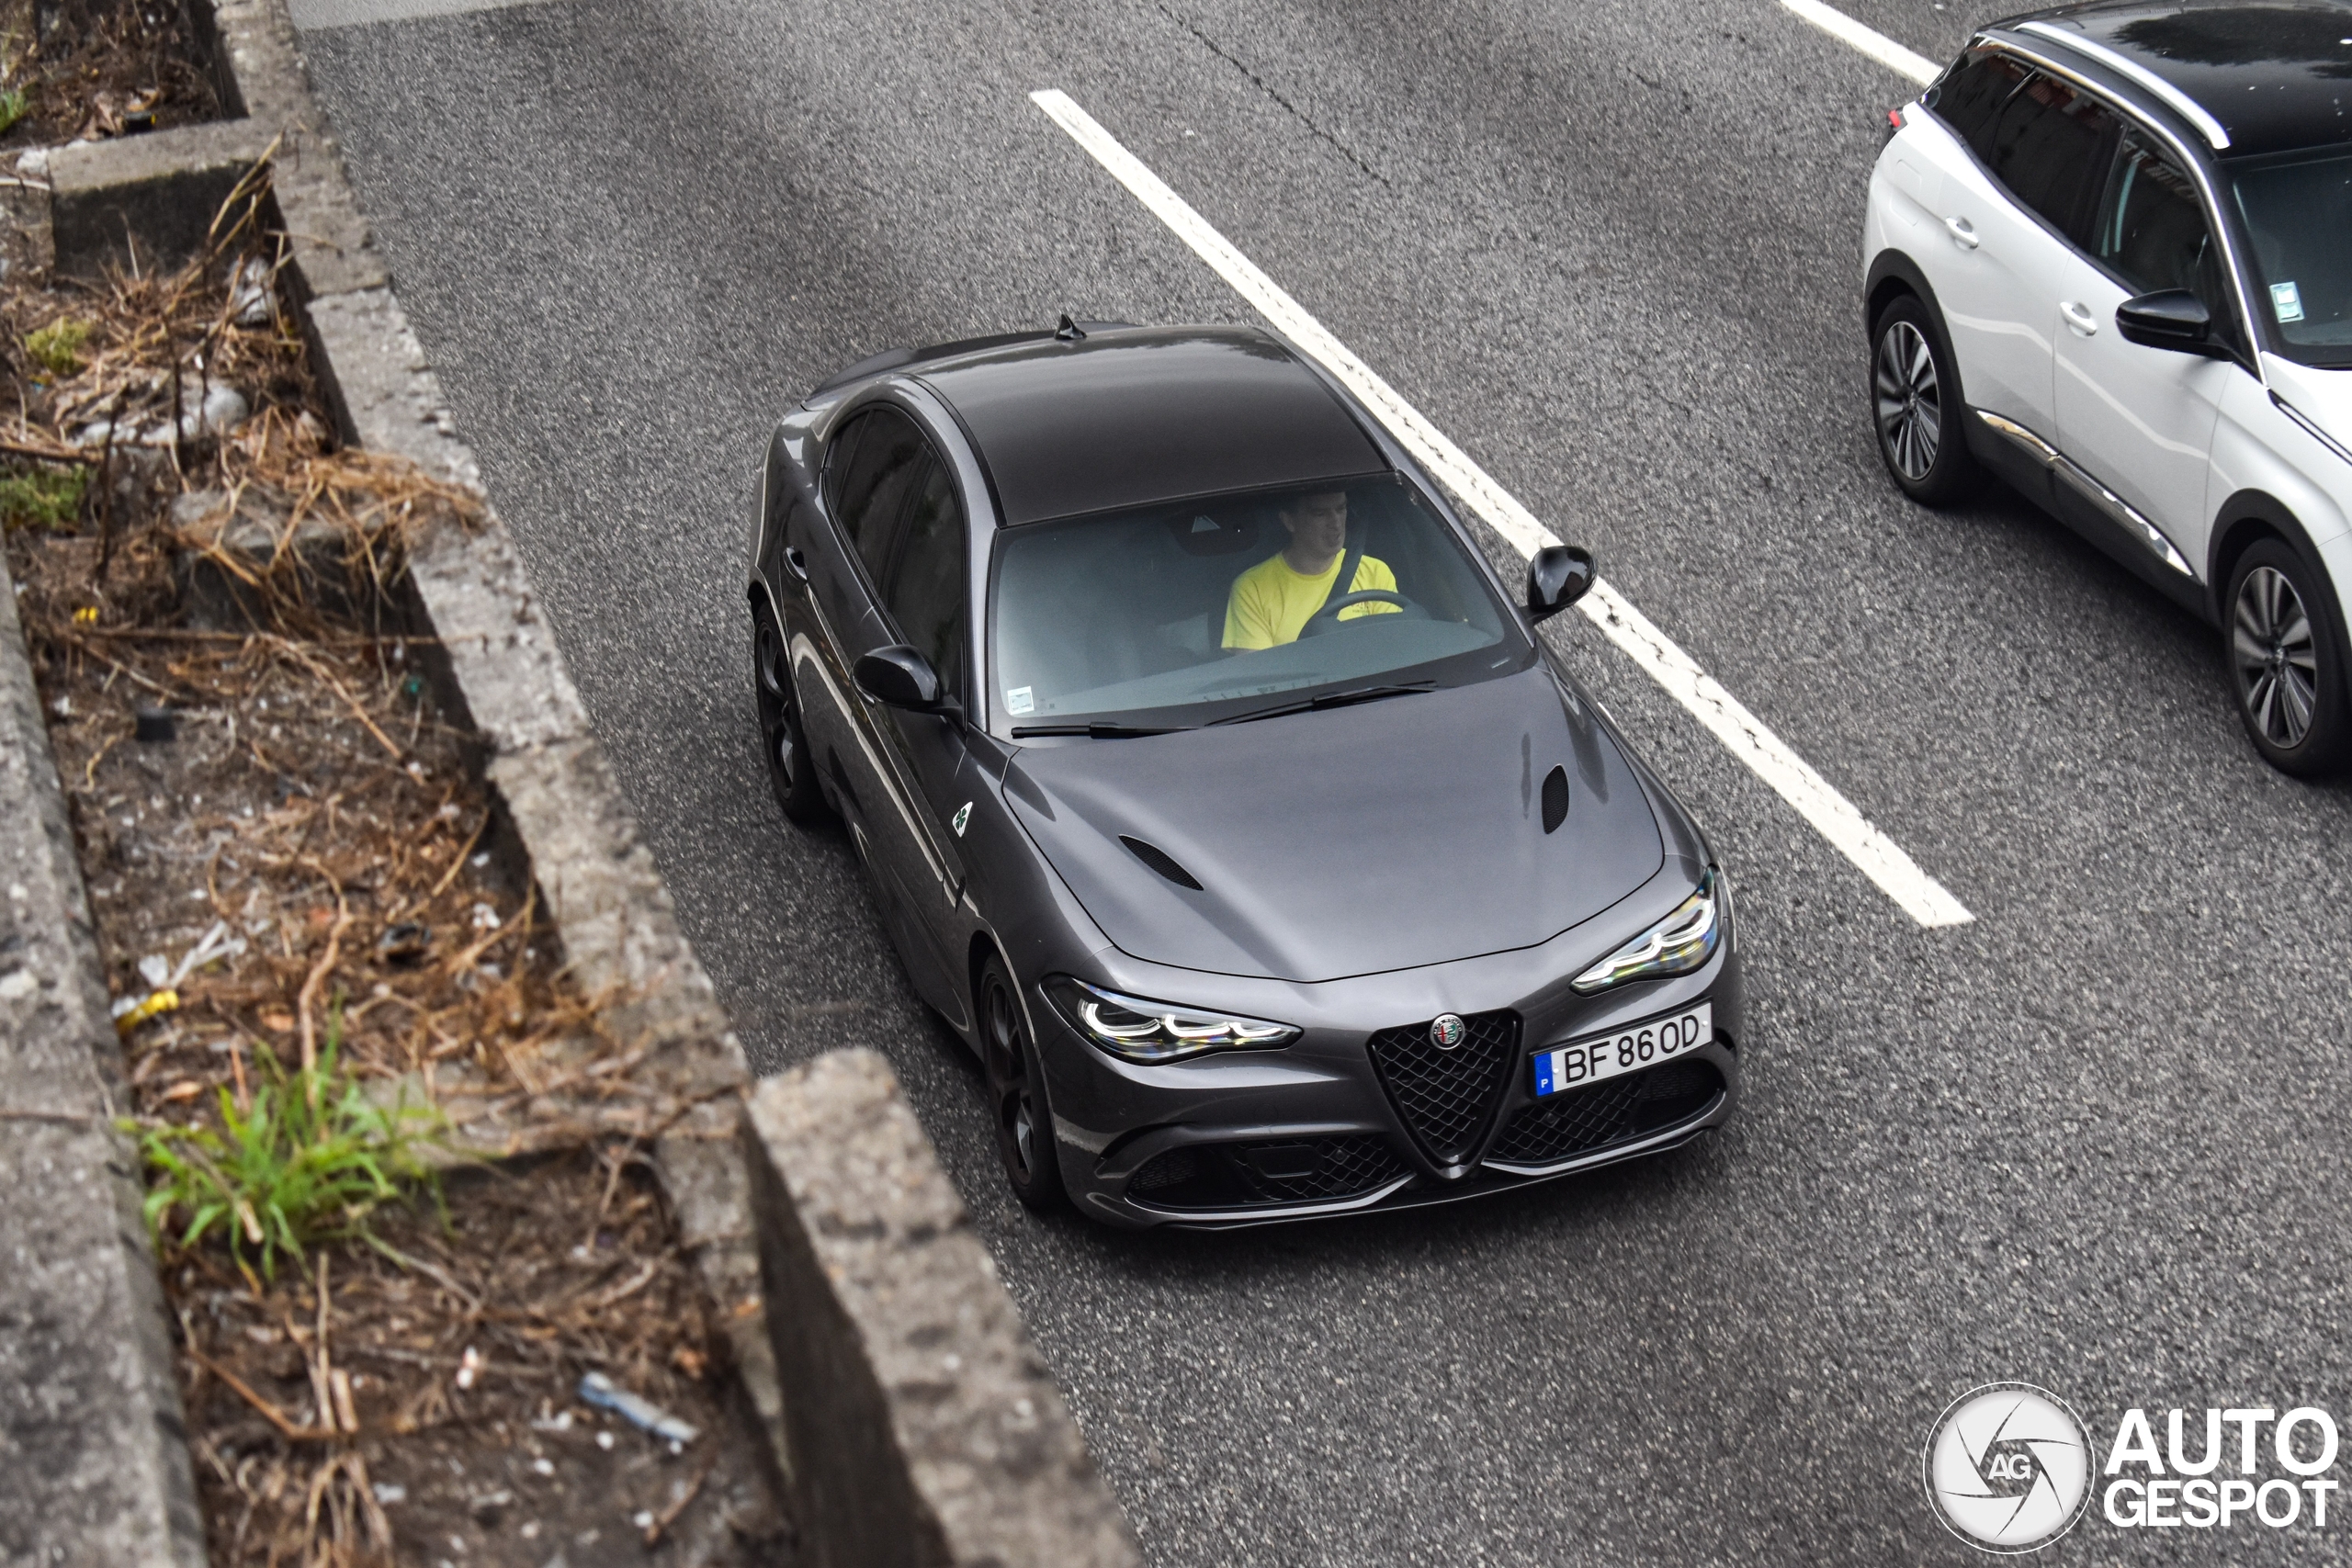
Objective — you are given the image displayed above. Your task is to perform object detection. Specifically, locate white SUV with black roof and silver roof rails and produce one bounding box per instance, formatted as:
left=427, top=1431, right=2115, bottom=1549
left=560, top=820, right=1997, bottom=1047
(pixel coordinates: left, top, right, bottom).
left=1863, top=0, right=2352, bottom=773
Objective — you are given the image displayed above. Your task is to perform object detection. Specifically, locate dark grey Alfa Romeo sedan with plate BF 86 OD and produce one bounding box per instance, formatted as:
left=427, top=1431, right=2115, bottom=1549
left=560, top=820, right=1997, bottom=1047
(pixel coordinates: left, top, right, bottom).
left=751, top=322, right=1740, bottom=1224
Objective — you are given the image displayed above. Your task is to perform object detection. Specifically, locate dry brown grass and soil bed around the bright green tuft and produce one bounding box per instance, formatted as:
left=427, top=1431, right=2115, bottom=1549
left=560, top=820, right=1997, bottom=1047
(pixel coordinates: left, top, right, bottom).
left=0, top=160, right=778, bottom=1568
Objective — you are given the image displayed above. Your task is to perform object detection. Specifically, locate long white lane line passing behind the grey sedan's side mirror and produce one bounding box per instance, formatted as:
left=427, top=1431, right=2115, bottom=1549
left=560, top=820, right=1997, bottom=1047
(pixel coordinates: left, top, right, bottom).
left=1030, top=87, right=1973, bottom=926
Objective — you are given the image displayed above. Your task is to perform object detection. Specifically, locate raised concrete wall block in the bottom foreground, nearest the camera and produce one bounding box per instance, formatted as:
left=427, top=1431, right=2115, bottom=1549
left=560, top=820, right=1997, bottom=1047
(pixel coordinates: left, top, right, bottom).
left=746, top=1051, right=1143, bottom=1568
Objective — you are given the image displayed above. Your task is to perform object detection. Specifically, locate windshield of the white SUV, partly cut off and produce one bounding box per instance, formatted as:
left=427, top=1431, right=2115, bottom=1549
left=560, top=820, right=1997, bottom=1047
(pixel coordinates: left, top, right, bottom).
left=2230, top=148, right=2352, bottom=367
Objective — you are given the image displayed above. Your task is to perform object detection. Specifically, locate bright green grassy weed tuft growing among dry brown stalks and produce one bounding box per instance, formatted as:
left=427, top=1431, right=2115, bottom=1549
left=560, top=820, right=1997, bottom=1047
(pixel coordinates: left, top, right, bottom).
left=125, top=1010, right=447, bottom=1279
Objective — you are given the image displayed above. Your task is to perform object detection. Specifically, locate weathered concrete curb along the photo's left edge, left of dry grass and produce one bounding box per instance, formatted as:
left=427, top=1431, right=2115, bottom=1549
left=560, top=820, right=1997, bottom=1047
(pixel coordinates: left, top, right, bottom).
left=0, top=545, right=205, bottom=1568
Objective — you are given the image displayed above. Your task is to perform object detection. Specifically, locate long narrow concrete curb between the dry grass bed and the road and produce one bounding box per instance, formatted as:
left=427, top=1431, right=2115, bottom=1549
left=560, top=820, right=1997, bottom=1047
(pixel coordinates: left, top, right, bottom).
left=183, top=0, right=783, bottom=1462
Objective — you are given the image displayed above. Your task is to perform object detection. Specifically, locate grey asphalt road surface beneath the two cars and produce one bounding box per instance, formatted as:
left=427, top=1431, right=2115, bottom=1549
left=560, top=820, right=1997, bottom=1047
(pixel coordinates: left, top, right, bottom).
left=299, top=0, right=2352, bottom=1568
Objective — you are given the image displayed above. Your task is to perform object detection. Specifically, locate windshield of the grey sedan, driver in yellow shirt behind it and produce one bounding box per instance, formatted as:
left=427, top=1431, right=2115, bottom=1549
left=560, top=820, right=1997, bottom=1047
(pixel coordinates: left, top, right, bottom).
left=990, top=475, right=1536, bottom=736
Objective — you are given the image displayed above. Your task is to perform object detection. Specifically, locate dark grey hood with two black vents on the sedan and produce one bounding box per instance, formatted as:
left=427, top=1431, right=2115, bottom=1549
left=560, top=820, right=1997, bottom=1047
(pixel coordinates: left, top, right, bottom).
left=1004, top=665, right=1665, bottom=980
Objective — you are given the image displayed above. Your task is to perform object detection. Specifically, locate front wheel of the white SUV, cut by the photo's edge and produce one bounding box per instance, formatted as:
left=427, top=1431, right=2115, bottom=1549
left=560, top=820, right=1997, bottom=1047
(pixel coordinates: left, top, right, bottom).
left=2225, top=538, right=2352, bottom=776
